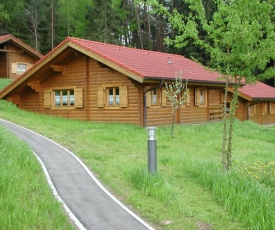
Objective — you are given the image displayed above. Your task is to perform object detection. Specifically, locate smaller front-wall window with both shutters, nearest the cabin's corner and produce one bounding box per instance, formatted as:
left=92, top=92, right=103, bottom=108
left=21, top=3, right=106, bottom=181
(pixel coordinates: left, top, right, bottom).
left=97, top=85, right=128, bottom=108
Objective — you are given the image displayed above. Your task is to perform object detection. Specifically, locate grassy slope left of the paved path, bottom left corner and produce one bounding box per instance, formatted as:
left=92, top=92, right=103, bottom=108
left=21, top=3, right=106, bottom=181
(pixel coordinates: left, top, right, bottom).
left=0, top=127, right=73, bottom=229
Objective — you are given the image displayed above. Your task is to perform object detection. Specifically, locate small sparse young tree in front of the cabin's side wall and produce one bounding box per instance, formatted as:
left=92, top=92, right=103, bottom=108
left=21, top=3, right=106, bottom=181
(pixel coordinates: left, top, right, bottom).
left=165, top=72, right=188, bottom=137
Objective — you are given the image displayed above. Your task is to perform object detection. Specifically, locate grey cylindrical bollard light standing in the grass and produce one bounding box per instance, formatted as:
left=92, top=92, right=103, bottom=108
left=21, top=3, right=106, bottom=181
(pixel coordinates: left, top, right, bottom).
left=147, top=127, right=157, bottom=173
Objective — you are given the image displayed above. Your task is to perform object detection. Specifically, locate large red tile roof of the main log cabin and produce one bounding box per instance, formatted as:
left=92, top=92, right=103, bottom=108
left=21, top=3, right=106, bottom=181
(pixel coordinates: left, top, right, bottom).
left=68, top=37, right=222, bottom=83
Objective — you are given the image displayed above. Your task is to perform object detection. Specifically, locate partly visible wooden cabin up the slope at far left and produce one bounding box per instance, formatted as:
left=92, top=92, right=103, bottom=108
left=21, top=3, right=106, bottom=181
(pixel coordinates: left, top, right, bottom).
left=0, top=34, right=43, bottom=79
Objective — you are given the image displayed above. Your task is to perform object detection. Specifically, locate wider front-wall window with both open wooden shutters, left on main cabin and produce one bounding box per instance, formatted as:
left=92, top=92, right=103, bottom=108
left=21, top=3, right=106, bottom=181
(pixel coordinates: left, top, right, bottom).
left=44, top=87, right=83, bottom=109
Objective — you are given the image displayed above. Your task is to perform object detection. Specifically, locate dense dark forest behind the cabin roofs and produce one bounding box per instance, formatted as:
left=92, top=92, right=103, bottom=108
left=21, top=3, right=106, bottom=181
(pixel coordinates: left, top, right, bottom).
left=0, top=0, right=215, bottom=64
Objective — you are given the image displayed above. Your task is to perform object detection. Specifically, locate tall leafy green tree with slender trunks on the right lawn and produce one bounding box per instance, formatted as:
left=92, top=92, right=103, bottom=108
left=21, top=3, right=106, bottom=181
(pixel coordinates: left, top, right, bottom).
left=152, top=0, right=275, bottom=170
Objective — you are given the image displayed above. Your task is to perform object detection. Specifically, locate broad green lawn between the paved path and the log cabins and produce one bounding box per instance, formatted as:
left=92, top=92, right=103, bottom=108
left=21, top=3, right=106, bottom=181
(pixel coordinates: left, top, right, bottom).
left=0, top=78, right=275, bottom=230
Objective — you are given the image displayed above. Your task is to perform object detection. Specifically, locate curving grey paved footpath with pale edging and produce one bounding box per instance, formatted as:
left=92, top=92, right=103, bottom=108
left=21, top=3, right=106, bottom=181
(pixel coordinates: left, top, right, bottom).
left=0, top=119, right=153, bottom=230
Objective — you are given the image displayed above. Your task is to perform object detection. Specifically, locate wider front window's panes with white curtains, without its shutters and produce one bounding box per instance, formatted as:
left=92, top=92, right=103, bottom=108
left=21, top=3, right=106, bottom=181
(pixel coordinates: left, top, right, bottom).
left=54, top=89, right=74, bottom=107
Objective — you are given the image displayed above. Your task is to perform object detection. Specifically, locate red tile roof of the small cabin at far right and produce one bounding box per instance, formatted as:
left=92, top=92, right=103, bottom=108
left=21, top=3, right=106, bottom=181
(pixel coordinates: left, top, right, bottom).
left=239, top=82, right=275, bottom=100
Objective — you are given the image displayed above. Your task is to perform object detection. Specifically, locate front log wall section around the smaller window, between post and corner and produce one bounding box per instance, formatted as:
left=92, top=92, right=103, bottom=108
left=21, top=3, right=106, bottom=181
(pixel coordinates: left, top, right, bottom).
left=88, top=59, right=143, bottom=125
